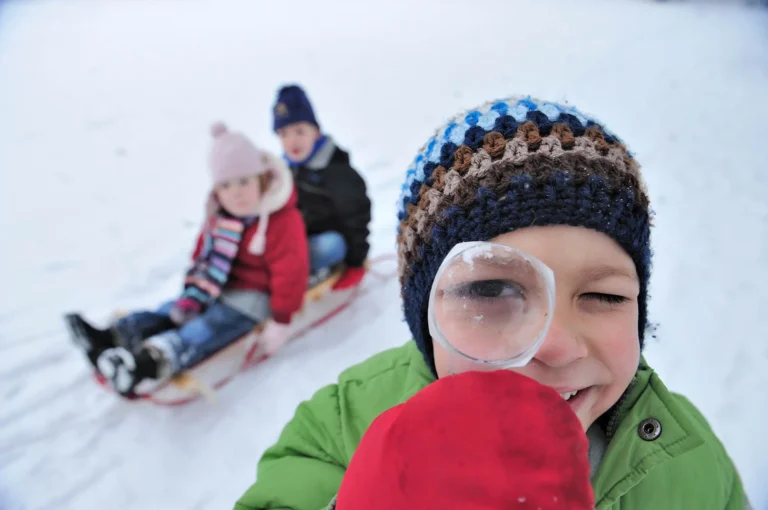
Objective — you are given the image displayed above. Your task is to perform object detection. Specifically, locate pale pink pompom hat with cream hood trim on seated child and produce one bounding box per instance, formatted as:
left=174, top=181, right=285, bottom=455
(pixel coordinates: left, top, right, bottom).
left=206, top=122, right=282, bottom=255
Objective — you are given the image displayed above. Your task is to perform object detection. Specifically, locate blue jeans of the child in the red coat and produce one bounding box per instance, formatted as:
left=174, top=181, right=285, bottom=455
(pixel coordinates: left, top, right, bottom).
left=115, top=301, right=256, bottom=373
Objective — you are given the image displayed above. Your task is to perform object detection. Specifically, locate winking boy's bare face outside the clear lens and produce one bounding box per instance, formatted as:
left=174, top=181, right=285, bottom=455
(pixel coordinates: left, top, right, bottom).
left=432, top=226, right=640, bottom=430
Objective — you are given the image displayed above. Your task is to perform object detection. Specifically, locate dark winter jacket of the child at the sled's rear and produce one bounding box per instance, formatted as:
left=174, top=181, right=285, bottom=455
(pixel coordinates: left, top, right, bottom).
left=291, top=137, right=371, bottom=267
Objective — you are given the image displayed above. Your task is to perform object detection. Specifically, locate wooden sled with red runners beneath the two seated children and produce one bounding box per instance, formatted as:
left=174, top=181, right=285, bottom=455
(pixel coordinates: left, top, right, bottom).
left=79, top=255, right=395, bottom=406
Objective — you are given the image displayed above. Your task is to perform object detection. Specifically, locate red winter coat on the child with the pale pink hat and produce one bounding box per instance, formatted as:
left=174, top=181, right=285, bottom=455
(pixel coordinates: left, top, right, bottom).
left=192, top=189, right=309, bottom=324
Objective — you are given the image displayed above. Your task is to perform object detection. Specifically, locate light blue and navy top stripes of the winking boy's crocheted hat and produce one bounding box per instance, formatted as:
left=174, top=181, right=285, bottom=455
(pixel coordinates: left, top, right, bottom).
left=397, top=96, right=632, bottom=223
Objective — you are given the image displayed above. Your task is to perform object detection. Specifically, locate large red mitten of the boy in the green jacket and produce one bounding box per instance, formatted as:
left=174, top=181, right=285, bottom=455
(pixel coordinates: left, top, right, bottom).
left=336, top=370, right=594, bottom=510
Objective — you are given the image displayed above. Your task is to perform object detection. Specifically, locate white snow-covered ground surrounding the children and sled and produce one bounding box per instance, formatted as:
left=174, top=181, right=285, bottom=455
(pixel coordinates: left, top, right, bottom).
left=0, top=0, right=768, bottom=510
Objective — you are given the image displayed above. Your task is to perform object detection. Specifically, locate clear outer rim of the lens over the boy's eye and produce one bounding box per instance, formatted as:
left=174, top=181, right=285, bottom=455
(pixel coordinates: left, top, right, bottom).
left=427, top=241, right=555, bottom=368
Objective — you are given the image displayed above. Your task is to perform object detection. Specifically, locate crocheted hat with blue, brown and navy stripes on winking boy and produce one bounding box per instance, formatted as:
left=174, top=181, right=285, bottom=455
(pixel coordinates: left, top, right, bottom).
left=397, top=97, right=651, bottom=371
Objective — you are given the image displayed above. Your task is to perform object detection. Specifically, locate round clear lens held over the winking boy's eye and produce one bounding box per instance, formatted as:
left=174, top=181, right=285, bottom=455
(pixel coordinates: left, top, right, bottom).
left=428, top=241, right=555, bottom=371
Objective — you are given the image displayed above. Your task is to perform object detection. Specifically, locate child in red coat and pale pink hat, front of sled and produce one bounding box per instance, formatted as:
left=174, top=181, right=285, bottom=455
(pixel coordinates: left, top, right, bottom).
left=67, top=123, right=309, bottom=396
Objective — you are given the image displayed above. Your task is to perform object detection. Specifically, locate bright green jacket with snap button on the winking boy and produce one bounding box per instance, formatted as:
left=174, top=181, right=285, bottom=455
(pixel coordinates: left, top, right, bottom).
left=235, top=342, right=750, bottom=510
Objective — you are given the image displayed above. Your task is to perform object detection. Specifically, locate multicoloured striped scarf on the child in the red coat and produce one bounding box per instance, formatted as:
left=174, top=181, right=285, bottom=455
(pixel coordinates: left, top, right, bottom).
left=176, top=215, right=246, bottom=313
